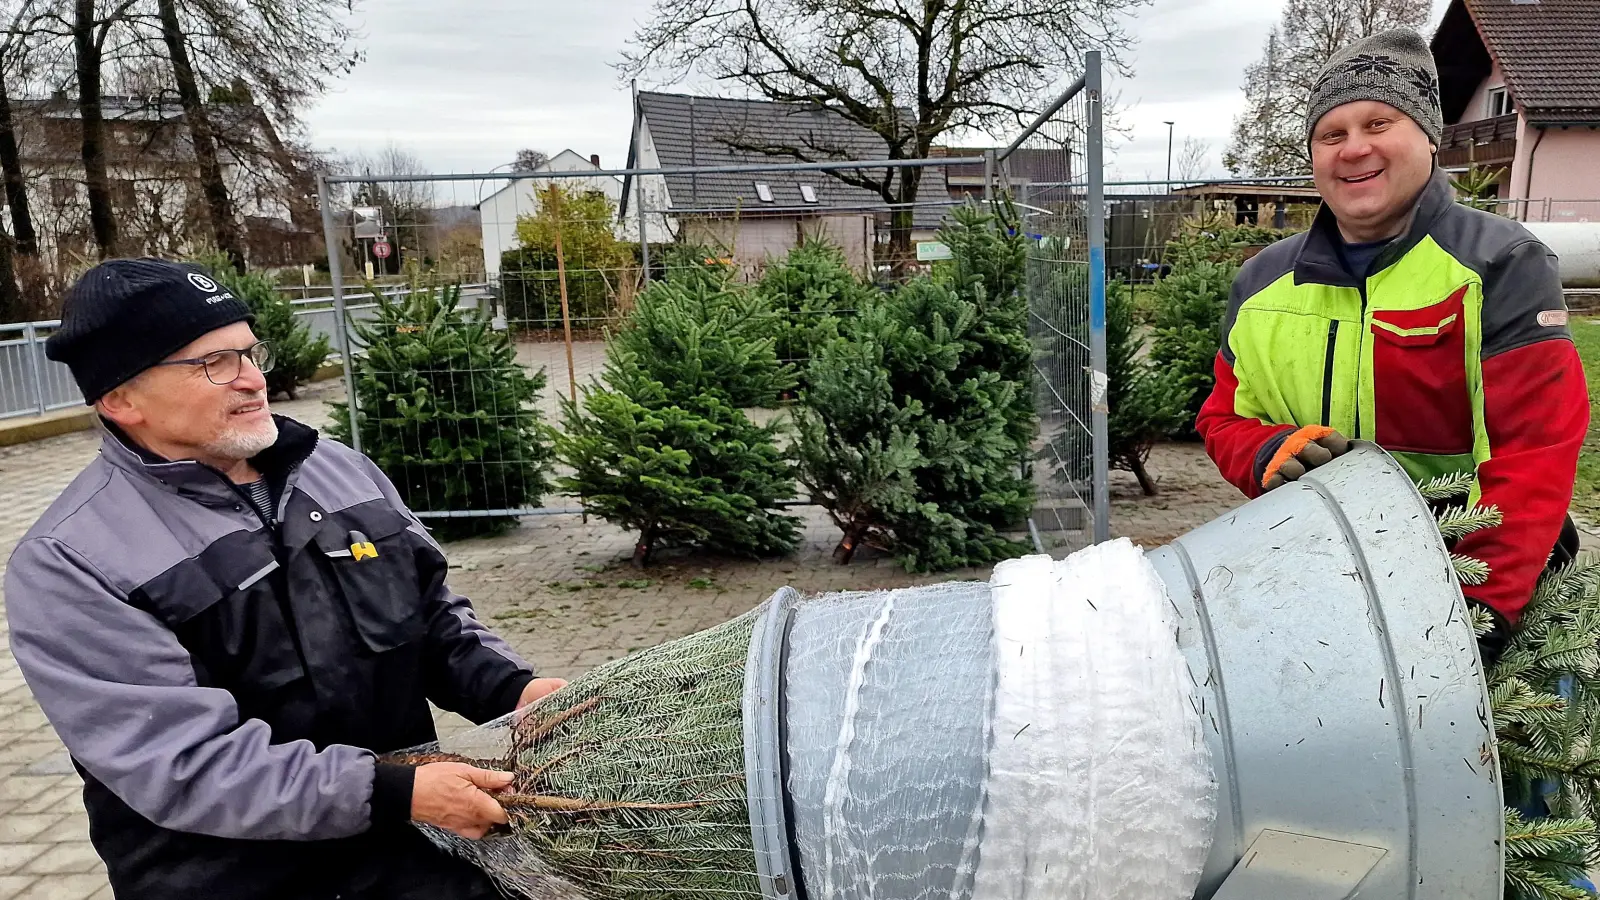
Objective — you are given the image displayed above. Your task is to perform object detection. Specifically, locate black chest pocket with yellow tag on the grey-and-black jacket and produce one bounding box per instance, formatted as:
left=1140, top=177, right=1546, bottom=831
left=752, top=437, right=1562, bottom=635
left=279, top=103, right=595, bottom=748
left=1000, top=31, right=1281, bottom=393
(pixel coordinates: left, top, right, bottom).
left=315, top=509, right=427, bottom=653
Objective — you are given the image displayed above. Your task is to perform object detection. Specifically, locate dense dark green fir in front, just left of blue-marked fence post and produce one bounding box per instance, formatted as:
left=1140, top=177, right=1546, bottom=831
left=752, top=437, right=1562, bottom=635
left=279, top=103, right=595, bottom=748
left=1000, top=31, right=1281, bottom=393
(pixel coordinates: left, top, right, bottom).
left=797, top=279, right=1034, bottom=572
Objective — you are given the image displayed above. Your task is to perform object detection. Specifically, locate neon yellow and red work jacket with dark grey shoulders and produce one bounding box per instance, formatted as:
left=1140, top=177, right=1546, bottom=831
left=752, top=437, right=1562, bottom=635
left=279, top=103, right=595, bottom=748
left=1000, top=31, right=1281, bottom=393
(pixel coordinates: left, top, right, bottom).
left=1197, top=170, right=1589, bottom=621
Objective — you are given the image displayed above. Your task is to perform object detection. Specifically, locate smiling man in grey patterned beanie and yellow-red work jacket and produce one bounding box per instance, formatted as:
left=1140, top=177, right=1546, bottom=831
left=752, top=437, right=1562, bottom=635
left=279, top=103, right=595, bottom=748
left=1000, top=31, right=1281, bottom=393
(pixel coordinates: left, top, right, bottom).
left=1197, top=29, right=1589, bottom=665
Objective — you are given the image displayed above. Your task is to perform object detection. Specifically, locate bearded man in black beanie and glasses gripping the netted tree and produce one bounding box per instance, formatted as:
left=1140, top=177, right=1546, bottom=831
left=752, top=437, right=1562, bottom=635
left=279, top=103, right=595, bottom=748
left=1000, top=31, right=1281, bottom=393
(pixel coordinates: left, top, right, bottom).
left=5, top=259, right=562, bottom=900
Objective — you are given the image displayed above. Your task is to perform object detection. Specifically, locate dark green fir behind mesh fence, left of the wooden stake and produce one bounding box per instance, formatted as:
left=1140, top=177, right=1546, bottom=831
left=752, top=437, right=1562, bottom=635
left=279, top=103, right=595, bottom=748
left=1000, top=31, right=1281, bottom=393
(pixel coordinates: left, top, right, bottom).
left=331, top=283, right=552, bottom=540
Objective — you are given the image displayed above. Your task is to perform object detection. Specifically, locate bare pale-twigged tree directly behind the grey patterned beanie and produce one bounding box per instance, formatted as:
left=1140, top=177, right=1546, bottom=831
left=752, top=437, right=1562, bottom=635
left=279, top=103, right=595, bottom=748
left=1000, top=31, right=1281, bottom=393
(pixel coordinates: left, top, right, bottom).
left=1222, top=0, right=1429, bottom=176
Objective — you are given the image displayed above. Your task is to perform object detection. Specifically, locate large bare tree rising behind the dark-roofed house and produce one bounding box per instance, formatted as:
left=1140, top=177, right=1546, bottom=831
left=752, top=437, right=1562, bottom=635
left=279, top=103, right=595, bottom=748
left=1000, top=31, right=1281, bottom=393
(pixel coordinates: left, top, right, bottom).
left=619, top=0, right=1146, bottom=255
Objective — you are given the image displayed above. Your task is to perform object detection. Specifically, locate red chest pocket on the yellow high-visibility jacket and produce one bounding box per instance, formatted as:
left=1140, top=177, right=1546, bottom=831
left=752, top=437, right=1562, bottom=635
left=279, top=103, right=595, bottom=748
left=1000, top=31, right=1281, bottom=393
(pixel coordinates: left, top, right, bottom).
left=1371, top=285, right=1472, bottom=455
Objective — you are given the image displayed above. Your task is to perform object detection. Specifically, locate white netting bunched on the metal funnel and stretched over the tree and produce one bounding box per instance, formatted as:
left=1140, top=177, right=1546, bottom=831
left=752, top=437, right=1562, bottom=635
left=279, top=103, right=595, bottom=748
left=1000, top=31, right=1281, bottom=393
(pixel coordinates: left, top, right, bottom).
left=396, top=541, right=1216, bottom=900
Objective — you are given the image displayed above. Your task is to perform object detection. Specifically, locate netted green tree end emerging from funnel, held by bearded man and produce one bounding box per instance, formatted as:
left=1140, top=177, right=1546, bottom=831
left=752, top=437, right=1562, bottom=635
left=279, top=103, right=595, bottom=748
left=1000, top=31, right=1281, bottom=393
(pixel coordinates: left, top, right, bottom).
left=387, top=609, right=762, bottom=900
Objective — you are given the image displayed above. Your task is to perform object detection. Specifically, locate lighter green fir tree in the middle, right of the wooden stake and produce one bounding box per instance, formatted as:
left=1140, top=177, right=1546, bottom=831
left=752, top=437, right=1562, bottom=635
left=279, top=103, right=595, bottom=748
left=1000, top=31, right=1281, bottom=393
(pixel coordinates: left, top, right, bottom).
left=557, top=267, right=798, bottom=567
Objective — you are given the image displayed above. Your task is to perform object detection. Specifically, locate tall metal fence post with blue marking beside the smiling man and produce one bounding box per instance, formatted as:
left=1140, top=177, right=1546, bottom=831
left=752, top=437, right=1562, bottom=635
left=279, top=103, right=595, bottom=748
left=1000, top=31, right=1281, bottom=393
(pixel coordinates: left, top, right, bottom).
left=1083, top=50, right=1110, bottom=543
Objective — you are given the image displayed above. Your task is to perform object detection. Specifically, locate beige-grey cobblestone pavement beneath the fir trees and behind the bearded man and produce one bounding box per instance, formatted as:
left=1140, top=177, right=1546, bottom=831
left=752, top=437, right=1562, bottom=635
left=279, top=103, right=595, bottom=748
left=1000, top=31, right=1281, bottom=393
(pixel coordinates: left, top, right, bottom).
left=0, top=343, right=987, bottom=900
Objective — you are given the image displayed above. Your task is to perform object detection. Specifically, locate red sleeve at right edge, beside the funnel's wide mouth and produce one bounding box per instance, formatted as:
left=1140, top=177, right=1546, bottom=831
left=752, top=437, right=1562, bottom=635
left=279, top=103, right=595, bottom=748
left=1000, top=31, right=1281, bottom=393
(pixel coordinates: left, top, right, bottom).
left=1456, top=340, right=1589, bottom=623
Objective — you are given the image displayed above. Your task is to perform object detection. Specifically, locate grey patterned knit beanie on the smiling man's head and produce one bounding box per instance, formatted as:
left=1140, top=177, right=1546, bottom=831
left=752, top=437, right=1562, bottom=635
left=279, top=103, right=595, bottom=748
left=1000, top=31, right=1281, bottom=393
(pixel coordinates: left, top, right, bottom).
left=1306, top=29, right=1445, bottom=146
